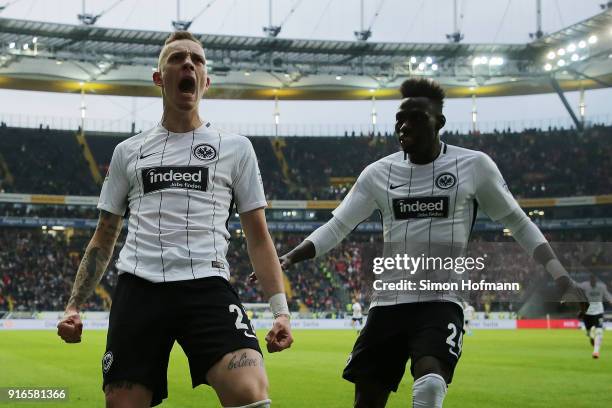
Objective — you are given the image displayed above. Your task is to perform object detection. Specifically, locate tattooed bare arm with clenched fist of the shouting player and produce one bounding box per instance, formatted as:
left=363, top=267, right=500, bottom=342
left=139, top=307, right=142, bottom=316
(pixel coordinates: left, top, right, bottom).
left=57, top=210, right=123, bottom=343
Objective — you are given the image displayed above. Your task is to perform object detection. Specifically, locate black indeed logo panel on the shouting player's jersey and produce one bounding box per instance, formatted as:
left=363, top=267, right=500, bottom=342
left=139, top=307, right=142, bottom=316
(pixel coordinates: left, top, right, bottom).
left=142, top=166, right=208, bottom=194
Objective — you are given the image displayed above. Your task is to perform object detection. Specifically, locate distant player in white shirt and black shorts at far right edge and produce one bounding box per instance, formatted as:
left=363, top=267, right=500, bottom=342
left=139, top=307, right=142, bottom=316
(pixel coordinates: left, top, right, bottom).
left=578, top=273, right=612, bottom=358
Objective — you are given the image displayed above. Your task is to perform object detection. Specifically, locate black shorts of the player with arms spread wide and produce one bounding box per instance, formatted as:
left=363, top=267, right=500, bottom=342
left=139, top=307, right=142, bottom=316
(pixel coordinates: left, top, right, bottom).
left=342, top=302, right=464, bottom=392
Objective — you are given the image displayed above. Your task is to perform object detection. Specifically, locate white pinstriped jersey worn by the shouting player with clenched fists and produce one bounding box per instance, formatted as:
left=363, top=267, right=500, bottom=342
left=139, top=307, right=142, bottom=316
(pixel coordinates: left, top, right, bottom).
left=98, top=123, right=266, bottom=282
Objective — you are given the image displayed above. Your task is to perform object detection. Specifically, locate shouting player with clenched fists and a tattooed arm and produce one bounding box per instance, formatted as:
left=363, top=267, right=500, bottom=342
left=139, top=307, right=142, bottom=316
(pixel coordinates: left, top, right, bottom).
left=58, top=32, right=293, bottom=408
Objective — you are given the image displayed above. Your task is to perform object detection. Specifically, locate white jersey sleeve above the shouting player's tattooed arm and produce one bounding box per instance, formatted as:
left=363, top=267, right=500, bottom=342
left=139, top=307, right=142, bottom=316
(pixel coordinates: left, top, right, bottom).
left=98, top=145, right=129, bottom=217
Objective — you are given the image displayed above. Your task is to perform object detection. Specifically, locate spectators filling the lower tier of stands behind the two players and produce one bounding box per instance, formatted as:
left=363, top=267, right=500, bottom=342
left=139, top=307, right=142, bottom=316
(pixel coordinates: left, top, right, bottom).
left=0, top=228, right=612, bottom=317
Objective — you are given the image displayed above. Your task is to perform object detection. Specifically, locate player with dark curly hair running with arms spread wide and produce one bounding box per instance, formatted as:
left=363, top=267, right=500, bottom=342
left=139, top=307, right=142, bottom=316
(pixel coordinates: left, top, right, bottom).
left=270, top=79, right=584, bottom=408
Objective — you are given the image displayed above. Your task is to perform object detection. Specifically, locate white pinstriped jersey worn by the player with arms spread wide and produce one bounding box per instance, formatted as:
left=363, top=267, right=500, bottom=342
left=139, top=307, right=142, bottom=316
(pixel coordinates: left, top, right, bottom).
left=333, top=143, right=520, bottom=307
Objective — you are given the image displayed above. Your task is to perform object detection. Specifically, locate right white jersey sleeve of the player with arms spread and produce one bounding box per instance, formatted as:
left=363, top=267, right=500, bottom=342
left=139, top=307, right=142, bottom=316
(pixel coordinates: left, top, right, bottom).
left=474, top=154, right=520, bottom=221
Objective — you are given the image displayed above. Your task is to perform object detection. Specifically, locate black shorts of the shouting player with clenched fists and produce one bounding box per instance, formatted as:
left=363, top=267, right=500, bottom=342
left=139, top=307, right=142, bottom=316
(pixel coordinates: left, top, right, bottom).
left=102, top=273, right=261, bottom=406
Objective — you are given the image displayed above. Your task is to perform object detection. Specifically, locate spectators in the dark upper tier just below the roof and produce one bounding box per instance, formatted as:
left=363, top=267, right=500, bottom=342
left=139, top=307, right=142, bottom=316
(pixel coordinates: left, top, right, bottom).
left=0, top=126, right=612, bottom=200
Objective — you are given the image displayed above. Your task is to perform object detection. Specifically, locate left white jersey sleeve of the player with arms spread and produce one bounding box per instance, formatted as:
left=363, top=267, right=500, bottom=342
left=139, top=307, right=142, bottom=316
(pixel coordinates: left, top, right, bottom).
left=332, top=166, right=376, bottom=230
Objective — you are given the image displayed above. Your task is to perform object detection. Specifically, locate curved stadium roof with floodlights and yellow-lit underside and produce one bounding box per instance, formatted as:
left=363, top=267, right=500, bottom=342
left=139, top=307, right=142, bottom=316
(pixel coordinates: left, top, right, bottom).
left=0, top=9, right=612, bottom=100
